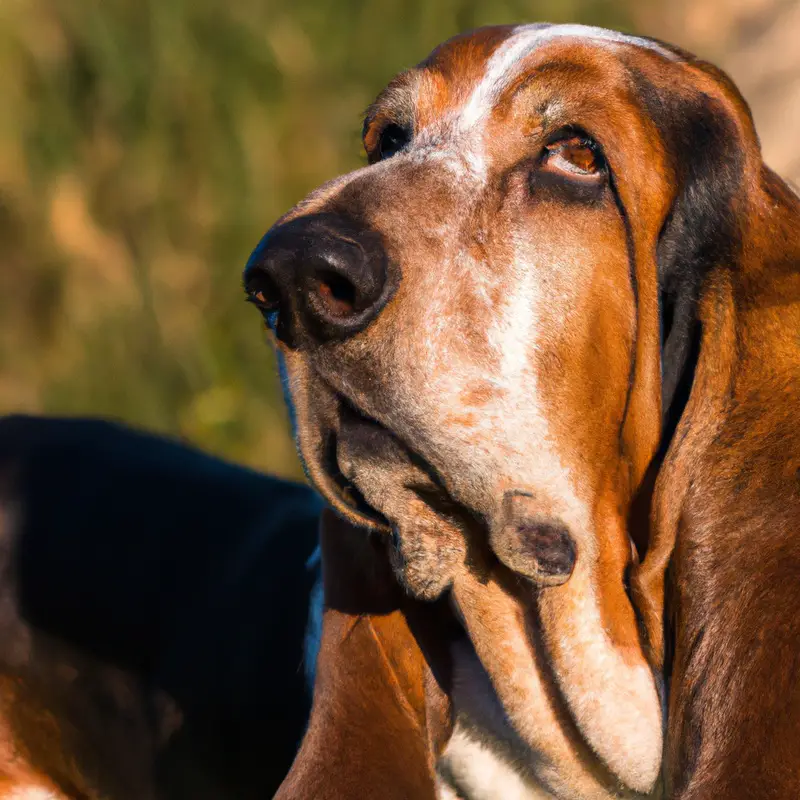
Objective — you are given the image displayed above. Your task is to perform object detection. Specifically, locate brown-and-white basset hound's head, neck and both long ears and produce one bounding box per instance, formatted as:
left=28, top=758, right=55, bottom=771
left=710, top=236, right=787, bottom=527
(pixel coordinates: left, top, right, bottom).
left=244, top=25, right=800, bottom=800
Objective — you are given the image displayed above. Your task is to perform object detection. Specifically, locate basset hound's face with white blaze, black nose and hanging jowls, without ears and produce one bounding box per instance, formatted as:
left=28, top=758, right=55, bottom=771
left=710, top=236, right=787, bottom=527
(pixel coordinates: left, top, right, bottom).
left=245, top=25, right=760, bottom=792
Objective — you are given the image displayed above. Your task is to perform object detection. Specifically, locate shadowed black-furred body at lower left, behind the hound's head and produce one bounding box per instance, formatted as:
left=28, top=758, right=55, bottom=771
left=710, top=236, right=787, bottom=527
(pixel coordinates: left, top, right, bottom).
left=0, top=416, right=322, bottom=800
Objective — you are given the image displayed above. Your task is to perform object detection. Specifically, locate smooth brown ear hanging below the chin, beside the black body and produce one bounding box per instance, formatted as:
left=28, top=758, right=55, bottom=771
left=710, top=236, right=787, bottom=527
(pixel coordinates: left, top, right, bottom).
left=276, top=511, right=450, bottom=800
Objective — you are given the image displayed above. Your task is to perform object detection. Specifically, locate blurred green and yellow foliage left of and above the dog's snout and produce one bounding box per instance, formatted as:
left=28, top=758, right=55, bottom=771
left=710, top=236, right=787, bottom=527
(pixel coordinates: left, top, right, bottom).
left=0, top=0, right=629, bottom=475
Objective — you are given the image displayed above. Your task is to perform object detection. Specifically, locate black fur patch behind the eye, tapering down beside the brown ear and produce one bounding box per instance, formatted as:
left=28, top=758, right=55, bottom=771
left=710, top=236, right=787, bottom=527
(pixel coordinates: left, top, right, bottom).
left=635, top=62, right=745, bottom=444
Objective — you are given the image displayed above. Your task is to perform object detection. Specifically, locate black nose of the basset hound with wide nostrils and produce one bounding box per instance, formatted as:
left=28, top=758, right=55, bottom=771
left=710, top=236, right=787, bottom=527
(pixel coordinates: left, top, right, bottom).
left=244, top=214, right=390, bottom=343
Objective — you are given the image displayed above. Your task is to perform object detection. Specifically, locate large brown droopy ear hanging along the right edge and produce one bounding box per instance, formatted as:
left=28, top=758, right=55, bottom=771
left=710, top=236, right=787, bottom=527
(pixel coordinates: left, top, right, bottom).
left=634, top=53, right=800, bottom=800
